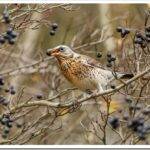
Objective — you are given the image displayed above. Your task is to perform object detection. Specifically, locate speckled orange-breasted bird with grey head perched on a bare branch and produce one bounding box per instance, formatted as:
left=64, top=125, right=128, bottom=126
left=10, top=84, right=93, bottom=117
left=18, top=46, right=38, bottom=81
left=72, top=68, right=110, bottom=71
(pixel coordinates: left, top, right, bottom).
left=46, top=45, right=133, bottom=93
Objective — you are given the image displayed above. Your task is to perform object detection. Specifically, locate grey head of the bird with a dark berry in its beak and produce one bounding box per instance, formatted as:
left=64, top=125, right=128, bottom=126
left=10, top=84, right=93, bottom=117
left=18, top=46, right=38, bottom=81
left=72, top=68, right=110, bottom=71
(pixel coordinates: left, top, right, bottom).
left=46, top=45, right=75, bottom=58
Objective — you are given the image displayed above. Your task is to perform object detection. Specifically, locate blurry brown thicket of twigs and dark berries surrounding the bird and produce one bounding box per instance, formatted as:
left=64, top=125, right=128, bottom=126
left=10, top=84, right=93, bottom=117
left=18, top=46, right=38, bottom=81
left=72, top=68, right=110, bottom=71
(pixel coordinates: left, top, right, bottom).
left=0, top=4, right=150, bottom=144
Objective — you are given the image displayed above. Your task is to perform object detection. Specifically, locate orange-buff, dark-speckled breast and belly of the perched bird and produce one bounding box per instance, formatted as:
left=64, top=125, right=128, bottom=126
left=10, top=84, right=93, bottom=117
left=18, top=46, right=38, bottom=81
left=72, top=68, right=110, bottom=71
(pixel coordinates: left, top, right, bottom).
left=60, top=61, right=97, bottom=90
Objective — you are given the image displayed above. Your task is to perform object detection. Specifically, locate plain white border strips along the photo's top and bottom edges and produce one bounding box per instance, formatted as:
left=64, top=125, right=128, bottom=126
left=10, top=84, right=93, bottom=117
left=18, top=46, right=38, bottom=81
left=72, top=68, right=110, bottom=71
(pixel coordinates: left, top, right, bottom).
left=0, top=0, right=150, bottom=149
